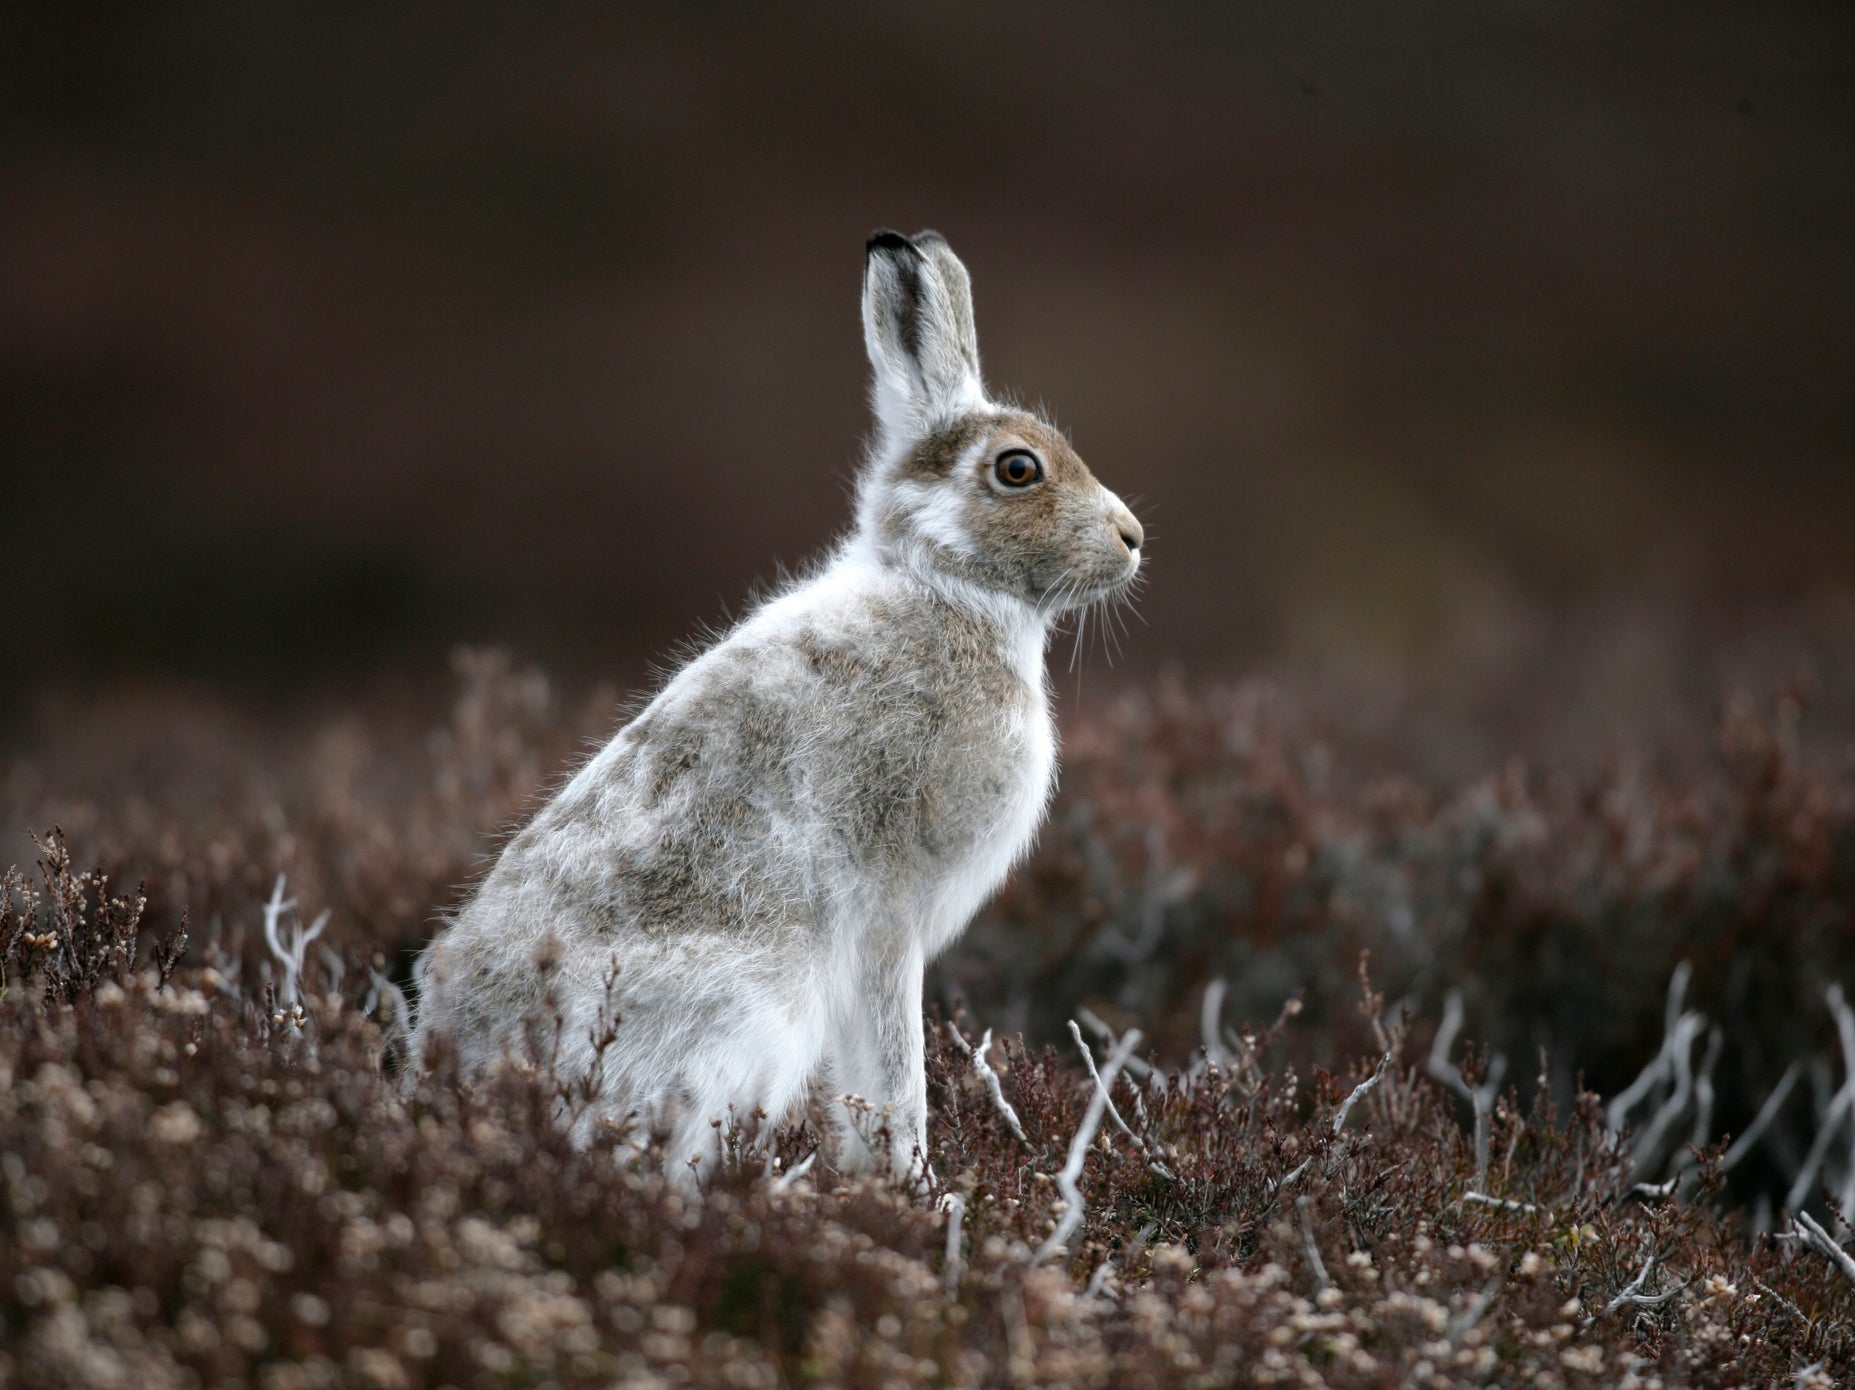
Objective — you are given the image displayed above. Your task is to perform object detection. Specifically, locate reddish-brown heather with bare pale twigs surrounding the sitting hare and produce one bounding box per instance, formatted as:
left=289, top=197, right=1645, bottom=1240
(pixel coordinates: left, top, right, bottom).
left=0, top=629, right=1855, bottom=1386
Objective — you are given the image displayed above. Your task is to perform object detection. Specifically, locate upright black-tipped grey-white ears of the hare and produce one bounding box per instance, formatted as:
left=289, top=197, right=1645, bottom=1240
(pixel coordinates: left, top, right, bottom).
left=863, top=232, right=985, bottom=445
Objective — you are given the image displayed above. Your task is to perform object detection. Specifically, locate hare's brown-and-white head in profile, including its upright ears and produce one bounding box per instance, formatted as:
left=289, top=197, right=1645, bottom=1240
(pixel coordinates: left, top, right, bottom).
left=857, top=232, right=1145, bottom=614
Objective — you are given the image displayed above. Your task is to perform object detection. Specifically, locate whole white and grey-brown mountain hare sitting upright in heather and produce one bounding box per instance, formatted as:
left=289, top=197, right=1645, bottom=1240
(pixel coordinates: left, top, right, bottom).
left=414, top=232, right=1143, bottom=1173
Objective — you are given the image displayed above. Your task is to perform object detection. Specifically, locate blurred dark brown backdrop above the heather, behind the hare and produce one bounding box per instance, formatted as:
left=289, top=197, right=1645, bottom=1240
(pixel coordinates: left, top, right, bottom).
left=0, top=0, right=1855, bottom=742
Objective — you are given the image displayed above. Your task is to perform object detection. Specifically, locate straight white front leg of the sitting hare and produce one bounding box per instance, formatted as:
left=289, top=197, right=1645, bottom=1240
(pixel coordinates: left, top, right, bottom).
left=831, top=943, right=928, bottom=1177
